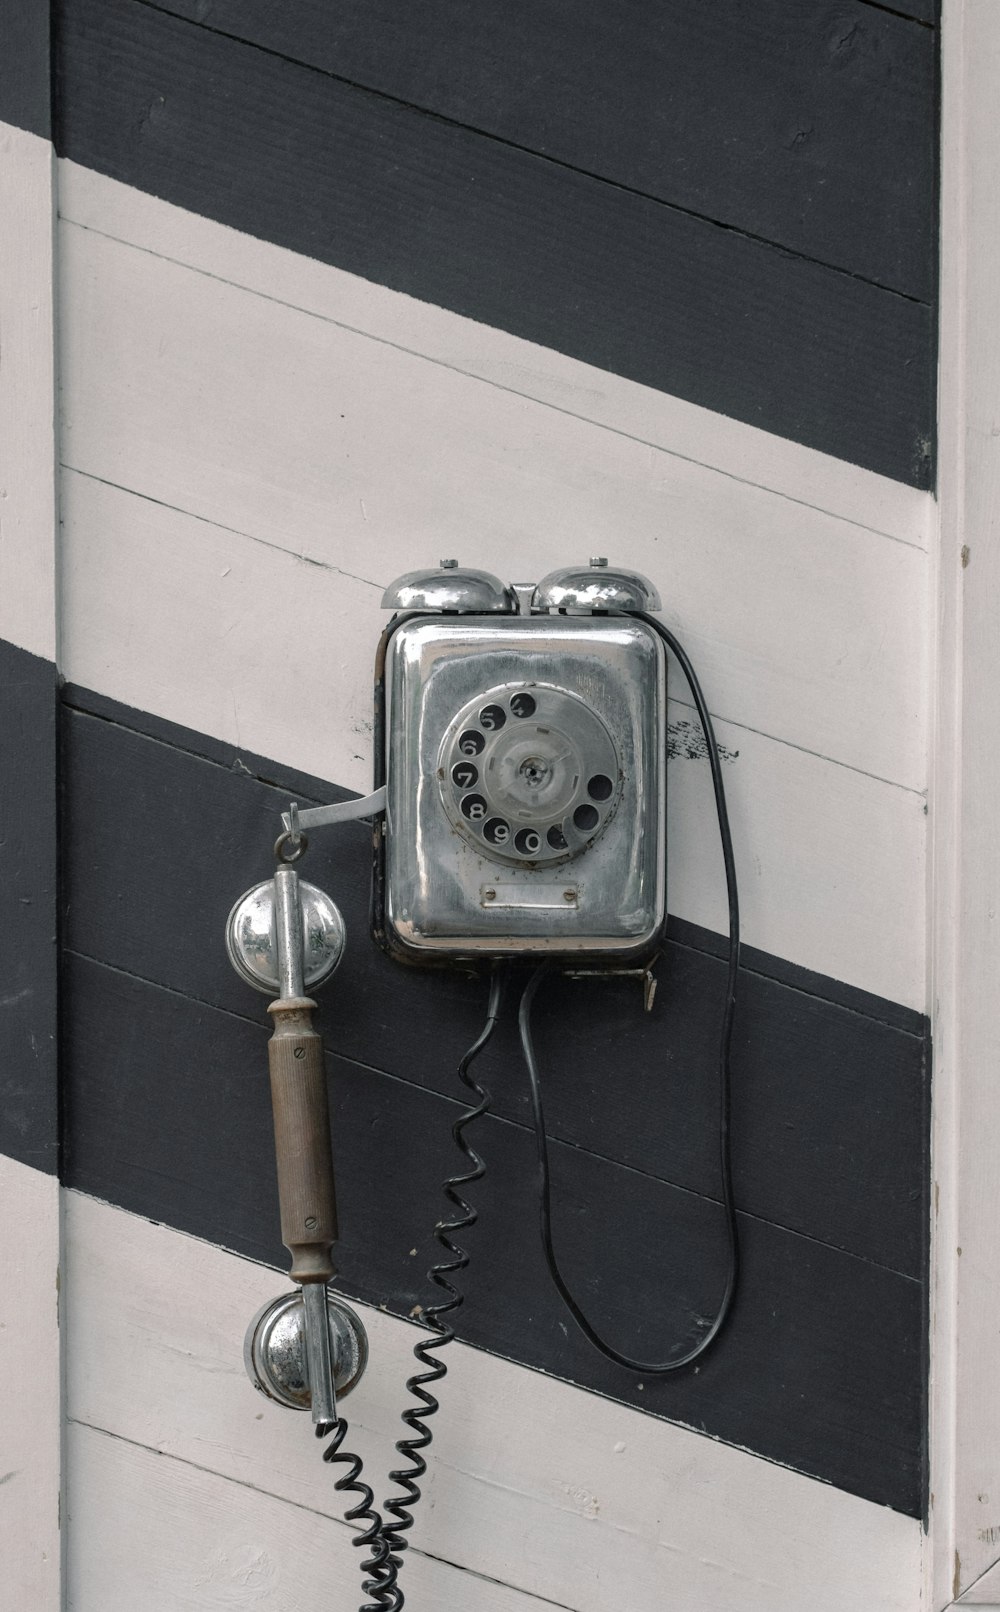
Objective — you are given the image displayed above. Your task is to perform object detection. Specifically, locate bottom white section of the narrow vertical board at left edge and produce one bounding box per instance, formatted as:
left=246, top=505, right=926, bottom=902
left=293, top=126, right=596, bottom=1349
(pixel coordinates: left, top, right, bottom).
left=0, top=1154, right=61, bottom=1612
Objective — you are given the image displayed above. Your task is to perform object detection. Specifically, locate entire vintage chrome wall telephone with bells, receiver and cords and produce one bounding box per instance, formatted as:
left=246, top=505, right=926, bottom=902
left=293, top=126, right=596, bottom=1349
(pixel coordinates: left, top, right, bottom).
left=226, top=559, right=739, bottom=1612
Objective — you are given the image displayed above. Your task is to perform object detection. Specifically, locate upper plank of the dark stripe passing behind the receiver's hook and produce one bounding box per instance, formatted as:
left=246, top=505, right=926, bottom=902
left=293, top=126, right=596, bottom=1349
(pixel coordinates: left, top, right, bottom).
left=65, top=686, right=927, bottom=1277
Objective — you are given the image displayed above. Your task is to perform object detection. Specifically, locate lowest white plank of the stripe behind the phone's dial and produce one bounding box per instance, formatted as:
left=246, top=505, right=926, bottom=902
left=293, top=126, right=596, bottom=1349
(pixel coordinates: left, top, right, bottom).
left=63, top=472, right=926, bottom=1008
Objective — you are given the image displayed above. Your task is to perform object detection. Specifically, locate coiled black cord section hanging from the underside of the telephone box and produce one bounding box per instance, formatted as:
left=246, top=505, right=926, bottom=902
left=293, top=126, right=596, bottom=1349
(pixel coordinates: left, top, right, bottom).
left=382, top=967, right=505, bottom=1573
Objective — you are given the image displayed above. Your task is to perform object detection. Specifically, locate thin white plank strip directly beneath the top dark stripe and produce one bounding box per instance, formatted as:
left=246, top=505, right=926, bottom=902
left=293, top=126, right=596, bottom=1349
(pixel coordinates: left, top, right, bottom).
left=60, top=161, right=934, bottom=546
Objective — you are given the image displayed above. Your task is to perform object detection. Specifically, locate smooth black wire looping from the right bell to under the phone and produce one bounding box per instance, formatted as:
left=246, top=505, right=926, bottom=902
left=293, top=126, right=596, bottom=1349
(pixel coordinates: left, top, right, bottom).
left=518, top=611, right=740, bottom=1377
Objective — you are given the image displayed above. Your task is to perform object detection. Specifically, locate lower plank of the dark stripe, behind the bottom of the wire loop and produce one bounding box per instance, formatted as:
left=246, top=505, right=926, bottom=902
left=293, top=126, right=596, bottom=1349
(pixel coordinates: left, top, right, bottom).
left=65, top=941, right=924, bottom=1514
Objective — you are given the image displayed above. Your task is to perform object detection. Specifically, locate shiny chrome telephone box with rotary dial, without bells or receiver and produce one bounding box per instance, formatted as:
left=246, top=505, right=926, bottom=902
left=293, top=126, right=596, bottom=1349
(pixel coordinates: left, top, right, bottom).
left=374, top=614, right=666, bottom=962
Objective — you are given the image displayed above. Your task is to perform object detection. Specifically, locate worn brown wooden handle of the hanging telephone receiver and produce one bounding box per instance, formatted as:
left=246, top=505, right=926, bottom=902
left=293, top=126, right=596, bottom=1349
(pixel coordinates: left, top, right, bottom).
left=268, top=996, right=337, bottom=1282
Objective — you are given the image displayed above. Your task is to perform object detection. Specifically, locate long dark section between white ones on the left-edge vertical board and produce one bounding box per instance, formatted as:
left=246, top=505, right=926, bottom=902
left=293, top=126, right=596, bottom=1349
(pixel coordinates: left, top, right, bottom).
left=0, top=640, right=58, bottom=1174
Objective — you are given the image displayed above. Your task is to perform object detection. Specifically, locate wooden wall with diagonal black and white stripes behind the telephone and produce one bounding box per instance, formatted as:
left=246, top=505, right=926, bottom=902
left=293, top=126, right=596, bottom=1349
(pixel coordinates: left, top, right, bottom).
left=0, top=0, right=961, bottom=1612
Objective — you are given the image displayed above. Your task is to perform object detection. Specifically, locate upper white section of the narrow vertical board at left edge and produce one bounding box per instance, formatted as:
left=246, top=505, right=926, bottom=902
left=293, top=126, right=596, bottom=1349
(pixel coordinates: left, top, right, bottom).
left=0, top=123, right=56, bottom=661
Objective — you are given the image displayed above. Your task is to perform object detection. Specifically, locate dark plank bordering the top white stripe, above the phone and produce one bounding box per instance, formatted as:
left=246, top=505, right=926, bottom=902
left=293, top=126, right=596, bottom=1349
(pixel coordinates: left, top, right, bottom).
left=58, top=0, right=934, bottom=487
